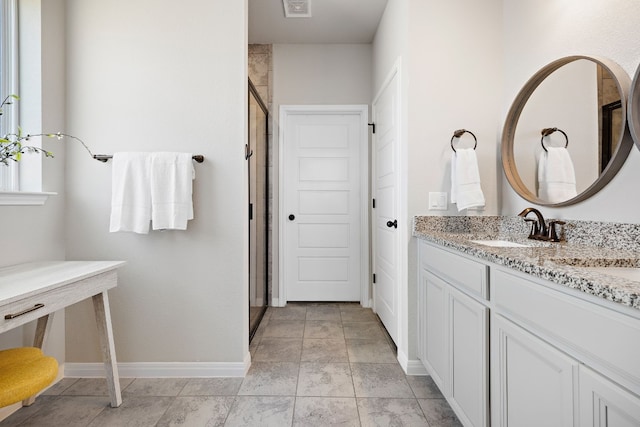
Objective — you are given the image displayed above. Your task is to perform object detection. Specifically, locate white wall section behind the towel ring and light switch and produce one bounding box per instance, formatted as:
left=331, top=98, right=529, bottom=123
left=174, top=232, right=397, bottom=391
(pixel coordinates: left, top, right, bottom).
left=373, top=0, right=502, bottom=368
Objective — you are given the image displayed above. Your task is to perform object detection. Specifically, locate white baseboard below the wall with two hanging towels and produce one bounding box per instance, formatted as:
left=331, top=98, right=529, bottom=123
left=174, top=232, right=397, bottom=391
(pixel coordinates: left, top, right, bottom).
left=64, top=352, right=251, bottom=378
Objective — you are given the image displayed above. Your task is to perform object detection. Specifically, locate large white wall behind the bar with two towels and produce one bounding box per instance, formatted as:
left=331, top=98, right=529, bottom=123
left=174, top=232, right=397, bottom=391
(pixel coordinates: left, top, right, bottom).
left=66, top=0, right=248, bottom=363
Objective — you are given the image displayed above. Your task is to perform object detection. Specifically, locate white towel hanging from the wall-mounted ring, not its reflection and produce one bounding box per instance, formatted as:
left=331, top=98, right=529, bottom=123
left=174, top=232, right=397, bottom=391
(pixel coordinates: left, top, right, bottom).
left=451, top=148, right=485, bottom=212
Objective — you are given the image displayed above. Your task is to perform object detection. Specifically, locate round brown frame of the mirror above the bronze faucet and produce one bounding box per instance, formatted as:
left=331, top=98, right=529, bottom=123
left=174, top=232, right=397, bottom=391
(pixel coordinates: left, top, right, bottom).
left=501, top=55, right=640, bottom=207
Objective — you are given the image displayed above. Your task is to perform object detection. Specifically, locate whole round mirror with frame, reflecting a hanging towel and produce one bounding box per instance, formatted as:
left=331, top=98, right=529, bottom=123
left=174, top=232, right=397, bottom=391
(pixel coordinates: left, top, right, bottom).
left=502, top=56, right=633, bottom=206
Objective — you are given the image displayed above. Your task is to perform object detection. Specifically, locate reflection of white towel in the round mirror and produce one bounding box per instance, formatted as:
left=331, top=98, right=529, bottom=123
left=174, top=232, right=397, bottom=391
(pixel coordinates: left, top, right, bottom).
left=538, top=147, right=577, bottom=203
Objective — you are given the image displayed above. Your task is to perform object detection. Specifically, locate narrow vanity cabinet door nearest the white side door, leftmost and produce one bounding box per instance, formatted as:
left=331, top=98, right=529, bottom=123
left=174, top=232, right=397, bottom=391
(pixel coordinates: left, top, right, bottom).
left=421, top=270, right=449, bottom=396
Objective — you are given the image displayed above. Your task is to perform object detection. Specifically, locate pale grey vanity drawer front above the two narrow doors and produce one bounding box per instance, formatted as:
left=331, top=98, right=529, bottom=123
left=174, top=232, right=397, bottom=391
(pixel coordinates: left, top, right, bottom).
left=420, top=240, right=489, bottom=299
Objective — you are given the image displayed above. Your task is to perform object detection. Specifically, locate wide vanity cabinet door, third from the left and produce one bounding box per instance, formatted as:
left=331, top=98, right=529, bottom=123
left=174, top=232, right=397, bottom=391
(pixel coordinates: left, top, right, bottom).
left=491, top=315, right=578, bottom=427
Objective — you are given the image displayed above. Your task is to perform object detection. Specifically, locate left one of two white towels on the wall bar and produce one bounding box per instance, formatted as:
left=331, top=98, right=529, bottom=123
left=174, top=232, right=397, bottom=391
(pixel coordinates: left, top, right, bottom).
left=109, top=153, right=151, bottom=234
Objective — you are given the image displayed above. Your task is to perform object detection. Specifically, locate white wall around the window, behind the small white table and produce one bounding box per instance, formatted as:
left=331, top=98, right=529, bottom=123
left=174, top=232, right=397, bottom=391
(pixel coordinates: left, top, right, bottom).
left=0, top=0, right=66, bottom=363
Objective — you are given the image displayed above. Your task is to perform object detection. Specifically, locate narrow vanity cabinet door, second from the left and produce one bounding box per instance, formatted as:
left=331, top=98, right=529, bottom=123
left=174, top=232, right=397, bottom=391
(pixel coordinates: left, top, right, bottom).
left=448, top=286, right=489, bottom=427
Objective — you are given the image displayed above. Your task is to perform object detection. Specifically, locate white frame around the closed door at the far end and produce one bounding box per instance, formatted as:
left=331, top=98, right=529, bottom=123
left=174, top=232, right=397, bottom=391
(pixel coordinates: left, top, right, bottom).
left=278, top=105, right=371, bottom=307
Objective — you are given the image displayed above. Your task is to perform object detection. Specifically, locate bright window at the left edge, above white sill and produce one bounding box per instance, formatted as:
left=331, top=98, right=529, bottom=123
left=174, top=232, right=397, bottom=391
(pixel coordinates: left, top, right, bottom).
left=0, top=0, right=19, bottom=191
